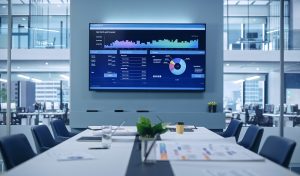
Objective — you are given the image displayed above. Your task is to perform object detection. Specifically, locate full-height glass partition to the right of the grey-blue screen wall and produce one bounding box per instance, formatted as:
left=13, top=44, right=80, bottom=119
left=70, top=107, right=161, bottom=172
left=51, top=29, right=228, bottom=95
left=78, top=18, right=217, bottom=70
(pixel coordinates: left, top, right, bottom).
left=224, top=0, right=300, bottom=127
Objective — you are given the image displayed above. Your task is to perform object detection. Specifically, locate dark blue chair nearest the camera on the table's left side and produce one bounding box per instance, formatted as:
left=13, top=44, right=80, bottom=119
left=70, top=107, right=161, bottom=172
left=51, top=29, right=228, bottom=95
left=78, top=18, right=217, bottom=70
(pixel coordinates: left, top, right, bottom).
left=0, top=134, right=36, bottom=170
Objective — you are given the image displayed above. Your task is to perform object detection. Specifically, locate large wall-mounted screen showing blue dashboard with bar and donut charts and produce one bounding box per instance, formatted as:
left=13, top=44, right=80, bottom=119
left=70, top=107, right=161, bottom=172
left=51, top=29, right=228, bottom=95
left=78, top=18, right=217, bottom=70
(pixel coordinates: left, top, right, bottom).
left=89, top=23, right=206, bottom=91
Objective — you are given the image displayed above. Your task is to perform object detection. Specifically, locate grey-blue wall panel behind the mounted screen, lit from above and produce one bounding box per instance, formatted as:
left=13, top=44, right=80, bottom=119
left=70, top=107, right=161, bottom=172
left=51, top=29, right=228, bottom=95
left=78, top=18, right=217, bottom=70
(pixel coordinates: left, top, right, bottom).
left=70, top=0, right=225, bottom=129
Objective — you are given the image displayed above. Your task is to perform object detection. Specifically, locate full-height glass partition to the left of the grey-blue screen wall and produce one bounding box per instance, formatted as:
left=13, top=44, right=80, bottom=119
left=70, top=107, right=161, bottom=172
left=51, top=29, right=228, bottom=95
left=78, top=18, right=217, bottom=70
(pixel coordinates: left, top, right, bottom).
left=0, top=0, right=70, bottom=125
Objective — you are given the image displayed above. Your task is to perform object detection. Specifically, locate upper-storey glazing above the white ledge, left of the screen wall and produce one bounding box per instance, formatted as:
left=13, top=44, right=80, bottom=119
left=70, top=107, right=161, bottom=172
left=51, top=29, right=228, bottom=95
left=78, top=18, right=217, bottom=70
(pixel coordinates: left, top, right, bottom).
left=0, top=0, right=70, bottom=49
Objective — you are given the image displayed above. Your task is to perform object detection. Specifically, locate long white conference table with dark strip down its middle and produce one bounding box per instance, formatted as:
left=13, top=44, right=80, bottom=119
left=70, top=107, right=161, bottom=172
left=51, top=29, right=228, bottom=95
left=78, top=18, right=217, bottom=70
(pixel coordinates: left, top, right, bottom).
left=4, top=127, right=297, bottom=176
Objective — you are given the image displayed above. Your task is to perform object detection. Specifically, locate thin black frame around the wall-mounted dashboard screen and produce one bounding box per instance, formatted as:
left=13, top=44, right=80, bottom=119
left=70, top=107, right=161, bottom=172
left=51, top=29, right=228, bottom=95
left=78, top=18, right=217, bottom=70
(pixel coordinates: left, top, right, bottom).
left=88, top=22, right=207, bottom=92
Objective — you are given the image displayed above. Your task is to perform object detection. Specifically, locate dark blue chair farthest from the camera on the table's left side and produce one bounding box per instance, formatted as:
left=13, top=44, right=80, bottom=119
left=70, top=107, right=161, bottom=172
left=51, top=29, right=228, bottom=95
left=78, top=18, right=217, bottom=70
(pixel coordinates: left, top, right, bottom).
left=50, top=119, right=76, bottom=142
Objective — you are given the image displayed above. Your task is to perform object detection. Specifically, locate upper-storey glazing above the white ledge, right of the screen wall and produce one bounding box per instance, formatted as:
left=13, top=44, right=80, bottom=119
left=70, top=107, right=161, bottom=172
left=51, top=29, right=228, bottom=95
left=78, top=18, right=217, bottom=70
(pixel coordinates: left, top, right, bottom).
left=224, top=0, right=295, bottom=51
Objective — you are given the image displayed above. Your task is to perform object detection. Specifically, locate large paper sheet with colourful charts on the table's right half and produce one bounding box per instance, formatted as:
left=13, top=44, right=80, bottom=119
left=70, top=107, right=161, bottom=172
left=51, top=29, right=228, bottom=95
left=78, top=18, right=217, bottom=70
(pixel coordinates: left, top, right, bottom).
left=156, top=141, right=264, bottom=161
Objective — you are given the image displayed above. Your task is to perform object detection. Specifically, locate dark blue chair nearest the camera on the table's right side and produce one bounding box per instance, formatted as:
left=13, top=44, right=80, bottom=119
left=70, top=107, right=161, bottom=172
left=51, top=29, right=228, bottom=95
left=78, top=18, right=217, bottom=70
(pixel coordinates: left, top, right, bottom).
left=259, top=136, right=296, bottom=168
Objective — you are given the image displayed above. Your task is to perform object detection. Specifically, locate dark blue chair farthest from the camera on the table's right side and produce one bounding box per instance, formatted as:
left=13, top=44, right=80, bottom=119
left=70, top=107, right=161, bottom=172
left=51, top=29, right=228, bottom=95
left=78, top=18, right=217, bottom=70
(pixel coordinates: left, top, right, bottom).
left=220, top=119, right=243, bottom=141
